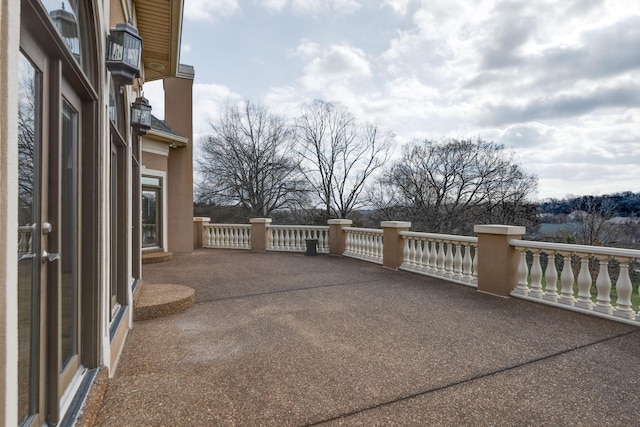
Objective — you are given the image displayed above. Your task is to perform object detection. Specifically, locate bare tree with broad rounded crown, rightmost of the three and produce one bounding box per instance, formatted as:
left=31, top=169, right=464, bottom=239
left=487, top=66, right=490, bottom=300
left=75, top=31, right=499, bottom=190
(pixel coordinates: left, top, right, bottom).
left=378, top=139, right=537, bottom=233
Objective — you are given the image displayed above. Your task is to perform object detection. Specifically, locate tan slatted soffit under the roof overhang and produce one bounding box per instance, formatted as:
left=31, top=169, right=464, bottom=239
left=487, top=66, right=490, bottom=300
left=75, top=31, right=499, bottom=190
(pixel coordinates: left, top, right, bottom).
left=135, top=0, right=183, bottom=82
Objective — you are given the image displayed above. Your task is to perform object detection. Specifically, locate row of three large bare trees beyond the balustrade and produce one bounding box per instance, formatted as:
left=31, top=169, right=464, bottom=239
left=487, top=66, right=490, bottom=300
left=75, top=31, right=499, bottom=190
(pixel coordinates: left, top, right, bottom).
left=195, top=100, right=538, bottom=234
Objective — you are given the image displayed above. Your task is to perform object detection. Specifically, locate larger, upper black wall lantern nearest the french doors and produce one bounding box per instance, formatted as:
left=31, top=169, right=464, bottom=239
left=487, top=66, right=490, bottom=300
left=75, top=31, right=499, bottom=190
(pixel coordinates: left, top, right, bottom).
left=107, top=22, right=142, bottom=85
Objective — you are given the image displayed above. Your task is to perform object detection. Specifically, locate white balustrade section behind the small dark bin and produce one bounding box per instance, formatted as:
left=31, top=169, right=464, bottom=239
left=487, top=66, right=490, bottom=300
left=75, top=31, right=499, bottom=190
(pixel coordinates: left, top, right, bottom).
left=267, top=225, right=329, bottom=253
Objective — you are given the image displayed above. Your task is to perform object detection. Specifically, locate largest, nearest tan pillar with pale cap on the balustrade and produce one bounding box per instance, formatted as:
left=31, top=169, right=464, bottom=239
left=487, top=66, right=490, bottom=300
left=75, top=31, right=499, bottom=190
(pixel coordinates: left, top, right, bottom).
left=473, top=225, right=526, bottom=297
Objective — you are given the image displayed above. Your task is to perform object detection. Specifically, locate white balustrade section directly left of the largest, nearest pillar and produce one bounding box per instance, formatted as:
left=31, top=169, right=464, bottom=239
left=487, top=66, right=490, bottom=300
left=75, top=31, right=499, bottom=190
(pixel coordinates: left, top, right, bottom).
left=400, top=231, right=478, bottom=287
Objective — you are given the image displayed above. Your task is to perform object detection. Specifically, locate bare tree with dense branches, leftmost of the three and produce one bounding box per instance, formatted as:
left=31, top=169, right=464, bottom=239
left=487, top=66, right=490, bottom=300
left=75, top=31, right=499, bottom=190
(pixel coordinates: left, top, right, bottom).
left=197, top=101, right=304, bottom=217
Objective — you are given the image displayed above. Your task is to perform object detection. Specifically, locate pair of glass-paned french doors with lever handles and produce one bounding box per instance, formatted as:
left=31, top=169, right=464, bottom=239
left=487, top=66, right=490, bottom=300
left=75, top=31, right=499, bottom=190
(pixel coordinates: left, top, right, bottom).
left=17, top=30, right=83, bottom=425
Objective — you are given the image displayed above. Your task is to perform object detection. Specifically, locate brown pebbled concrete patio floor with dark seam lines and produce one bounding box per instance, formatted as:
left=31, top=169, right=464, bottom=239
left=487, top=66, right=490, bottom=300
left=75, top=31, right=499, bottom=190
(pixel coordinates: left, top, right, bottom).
left=97, top=250, right=640, bottom=426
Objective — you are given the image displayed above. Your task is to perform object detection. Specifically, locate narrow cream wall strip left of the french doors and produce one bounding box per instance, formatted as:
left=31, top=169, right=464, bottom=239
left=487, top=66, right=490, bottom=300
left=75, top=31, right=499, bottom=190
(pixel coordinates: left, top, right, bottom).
left=0, top=0, right=20, bottom=426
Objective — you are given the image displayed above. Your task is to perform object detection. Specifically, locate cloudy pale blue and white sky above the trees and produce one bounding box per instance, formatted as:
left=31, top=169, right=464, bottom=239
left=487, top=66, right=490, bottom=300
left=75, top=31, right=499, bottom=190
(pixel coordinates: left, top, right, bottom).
left=145, top=0, right=640, bottom=199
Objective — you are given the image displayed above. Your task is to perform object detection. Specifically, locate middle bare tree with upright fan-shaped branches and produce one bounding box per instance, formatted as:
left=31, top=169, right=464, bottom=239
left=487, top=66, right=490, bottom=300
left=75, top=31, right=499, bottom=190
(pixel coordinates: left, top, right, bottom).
left=296, top=100, right=395, bottom=218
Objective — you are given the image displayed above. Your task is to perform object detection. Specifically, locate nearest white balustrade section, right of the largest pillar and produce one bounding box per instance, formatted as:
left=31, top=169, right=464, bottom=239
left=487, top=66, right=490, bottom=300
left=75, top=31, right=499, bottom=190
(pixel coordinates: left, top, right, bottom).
left=511, top=240, right=640, bottom=325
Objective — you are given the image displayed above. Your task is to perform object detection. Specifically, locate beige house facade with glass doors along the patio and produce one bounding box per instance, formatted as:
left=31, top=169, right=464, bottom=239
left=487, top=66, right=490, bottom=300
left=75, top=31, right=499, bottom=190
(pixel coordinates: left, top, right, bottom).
left=0, top=0, right=193, bottom=426
